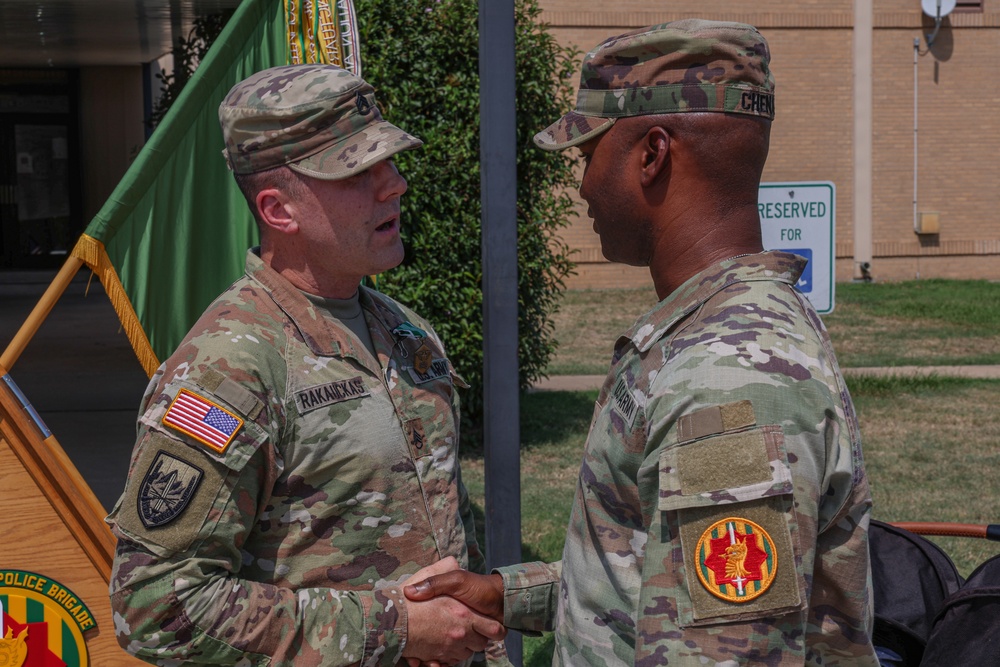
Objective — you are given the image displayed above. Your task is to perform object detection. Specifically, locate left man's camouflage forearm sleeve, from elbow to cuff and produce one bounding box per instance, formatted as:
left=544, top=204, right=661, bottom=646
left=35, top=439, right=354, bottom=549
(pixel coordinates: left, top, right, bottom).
left=111, top=540, right=406, bottom=666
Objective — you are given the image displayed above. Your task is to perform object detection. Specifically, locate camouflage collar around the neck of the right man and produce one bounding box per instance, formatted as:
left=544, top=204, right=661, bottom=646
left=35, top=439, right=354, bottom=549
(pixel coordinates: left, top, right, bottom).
left=618, top=251, right=807, bottom=352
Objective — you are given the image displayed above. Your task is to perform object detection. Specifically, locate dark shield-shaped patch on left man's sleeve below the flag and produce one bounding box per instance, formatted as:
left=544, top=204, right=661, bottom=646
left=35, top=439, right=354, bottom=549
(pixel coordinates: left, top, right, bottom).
left=136, top=451, right=204, bottom=528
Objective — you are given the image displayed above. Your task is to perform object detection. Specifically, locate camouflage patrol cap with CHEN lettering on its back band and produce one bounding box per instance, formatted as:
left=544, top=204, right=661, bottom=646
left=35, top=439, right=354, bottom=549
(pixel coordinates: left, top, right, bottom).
left=535, top=19, right=774, bottom=151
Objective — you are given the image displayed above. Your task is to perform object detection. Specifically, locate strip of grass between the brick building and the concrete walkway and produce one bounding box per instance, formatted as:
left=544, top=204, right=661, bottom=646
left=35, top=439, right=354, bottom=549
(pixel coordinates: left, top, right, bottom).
left=548, top=280, right=1000, bottom=375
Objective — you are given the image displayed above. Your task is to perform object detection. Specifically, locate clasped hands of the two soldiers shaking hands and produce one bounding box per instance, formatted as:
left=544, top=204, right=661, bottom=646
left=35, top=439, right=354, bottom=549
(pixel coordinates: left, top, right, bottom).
left=403, top=556, right=507, bottom=667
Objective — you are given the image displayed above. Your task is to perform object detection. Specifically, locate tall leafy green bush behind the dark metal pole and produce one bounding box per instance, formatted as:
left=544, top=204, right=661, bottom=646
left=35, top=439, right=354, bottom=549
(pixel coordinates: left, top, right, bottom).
left=355, top=0, right=576, bottom=445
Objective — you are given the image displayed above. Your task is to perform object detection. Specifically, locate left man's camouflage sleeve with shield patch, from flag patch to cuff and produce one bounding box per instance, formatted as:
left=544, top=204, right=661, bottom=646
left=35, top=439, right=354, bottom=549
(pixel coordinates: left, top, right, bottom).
left=108, top=394, right=406, bottom=666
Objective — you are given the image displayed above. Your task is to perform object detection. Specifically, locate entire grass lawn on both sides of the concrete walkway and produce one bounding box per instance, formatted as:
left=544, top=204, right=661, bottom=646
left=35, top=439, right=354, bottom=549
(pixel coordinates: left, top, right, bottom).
left=462, top=280, right=1000, bottom=667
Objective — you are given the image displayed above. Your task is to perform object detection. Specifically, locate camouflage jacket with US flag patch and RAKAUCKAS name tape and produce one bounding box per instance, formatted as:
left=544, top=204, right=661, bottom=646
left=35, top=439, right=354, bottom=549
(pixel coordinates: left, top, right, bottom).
left=108, top=251, right=496, bottom=667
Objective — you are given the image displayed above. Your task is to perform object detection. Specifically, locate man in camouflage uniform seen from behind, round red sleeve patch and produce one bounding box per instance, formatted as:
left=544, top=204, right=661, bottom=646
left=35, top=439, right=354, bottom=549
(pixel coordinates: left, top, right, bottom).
left=406, top=20, right=877, bottom=666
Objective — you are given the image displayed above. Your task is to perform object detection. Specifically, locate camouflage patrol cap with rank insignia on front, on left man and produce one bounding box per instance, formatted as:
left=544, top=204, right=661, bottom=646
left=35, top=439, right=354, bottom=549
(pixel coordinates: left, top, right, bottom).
left=219, top=64, right=421, bottom=180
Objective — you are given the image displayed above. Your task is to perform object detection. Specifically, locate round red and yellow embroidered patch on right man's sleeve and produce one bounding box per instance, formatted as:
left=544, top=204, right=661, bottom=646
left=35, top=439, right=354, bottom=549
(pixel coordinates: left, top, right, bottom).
left=694, top=517, right=778, bottom=602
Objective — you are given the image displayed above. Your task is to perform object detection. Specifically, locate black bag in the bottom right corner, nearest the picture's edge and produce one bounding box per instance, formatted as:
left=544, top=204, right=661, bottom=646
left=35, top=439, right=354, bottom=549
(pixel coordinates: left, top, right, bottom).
left=921, top=556, right=1000, bottom=667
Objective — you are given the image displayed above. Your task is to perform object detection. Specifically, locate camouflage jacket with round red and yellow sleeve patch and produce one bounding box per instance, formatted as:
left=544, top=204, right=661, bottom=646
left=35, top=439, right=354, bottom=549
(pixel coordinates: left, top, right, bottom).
left=501, top=252, right=877, bottom=666
